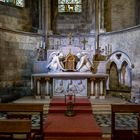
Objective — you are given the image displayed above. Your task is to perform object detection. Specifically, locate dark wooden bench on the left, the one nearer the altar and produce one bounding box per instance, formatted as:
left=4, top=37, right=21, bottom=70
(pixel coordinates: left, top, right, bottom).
left=0, top=103, right=44, bottom=137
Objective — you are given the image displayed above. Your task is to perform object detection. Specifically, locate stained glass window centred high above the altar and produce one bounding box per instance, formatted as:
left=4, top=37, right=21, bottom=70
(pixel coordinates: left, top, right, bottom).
left=58, top=0, right=82, bottom=13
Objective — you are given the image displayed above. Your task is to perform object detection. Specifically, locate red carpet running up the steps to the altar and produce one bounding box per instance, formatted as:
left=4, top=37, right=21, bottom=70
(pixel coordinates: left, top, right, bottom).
left=44, top=98, right=102, bottom=140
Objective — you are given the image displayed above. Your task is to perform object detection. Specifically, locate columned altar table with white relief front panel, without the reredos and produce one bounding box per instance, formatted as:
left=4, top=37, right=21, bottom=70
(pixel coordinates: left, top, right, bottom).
left=31, top=72, right=108, bottom=99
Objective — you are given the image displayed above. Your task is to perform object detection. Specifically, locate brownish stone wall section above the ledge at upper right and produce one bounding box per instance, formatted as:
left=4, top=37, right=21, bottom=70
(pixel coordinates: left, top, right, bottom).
left=111, top=0, right=137, bottom=31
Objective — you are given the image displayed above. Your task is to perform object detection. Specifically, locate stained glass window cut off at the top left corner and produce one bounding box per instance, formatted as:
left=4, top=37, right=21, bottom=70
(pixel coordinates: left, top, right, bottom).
left=0, top=0, right=25, bottom=7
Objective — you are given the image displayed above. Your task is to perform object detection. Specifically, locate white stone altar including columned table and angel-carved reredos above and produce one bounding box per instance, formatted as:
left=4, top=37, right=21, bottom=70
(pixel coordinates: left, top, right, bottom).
left=31, top=44, right=108, bottom=99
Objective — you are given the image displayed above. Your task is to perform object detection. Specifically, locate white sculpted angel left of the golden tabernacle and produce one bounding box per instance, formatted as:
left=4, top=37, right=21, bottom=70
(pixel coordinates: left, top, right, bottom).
left=46, top=51, right=65, bottom=72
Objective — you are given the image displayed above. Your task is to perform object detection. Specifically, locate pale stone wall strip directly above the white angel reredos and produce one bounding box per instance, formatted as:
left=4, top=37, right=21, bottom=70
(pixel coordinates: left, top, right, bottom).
left=47, top=34, right=95, bottom=53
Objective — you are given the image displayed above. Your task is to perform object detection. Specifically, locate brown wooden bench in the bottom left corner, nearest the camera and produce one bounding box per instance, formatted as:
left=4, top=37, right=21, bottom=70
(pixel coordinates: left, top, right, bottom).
left=0, top=119, right=32, bottom=140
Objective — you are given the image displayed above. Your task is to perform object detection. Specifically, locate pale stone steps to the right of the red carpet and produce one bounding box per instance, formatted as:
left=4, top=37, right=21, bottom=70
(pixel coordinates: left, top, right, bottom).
left=92, top=104, right=111, bottom=114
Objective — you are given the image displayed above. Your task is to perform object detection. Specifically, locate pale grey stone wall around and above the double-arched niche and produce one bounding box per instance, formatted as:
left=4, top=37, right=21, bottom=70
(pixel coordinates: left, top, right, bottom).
left=99, top=26, right=140, bottom=92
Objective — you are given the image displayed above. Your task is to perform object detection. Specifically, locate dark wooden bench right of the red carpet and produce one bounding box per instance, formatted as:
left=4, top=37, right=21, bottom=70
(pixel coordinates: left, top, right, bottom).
left=111, top=104, right=140, bottom=140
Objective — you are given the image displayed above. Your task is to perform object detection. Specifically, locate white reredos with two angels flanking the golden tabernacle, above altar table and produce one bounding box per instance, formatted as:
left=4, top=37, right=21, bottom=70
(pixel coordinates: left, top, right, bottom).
left=47, top=45, right=93, bottom=72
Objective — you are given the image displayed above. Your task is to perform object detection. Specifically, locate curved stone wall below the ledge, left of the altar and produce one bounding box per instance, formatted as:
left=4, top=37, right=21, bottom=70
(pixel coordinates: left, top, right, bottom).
left=0, top=29, right=42, bottom=102
